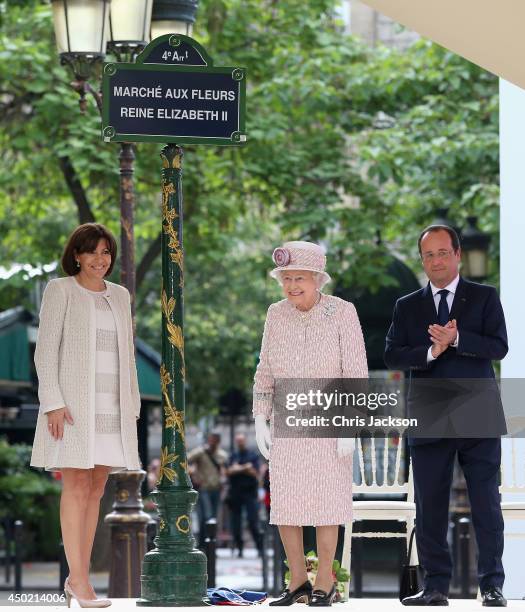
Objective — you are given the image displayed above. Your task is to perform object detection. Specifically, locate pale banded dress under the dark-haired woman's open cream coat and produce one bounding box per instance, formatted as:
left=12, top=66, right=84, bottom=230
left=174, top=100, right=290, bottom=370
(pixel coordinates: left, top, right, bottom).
left=83, top=288, right=126, bottom=471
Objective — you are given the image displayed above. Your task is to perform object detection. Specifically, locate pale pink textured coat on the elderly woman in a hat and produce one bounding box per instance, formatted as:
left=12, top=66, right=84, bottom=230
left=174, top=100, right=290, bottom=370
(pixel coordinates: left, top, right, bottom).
left=253, top=294, right=368, bottom=526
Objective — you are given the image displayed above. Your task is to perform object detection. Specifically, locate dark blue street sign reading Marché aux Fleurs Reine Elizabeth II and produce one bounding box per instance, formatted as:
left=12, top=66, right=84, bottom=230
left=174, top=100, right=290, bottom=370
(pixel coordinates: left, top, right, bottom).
left=102, top=34, right=246, bottom=145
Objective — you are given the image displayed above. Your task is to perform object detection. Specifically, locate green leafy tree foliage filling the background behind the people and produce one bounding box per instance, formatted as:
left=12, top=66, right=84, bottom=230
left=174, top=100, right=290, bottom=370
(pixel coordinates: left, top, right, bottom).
left=0, top=0, right=499, bottom=416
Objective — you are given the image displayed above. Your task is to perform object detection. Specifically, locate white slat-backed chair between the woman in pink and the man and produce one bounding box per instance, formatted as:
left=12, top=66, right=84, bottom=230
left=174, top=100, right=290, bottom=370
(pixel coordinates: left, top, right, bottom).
left=341, top=436, right=417, bottom=599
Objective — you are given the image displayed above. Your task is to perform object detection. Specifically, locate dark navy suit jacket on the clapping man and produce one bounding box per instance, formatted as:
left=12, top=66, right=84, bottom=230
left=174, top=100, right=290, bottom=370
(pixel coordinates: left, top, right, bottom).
left=384, top=278, right=508, bottom=444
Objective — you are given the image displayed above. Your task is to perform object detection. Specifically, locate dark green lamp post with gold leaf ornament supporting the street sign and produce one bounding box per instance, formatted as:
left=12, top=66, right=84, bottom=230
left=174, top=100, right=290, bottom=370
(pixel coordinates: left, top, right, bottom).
left=137, top=0, right=207, bottom=606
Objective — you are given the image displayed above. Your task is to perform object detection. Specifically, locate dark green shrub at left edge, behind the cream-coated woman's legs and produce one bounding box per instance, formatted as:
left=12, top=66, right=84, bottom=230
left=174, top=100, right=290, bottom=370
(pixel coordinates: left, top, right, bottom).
left=0, top=438, right=60, bottom=559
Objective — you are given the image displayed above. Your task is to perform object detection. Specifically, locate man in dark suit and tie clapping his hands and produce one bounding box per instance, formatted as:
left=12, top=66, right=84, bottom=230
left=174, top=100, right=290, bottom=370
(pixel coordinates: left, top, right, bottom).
left=385, top=225, right=508, bottom=606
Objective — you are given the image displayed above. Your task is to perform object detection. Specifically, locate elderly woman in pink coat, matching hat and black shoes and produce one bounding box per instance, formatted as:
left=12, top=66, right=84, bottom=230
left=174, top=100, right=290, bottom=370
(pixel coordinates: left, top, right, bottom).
left=253, top=241, right=368, bottom=606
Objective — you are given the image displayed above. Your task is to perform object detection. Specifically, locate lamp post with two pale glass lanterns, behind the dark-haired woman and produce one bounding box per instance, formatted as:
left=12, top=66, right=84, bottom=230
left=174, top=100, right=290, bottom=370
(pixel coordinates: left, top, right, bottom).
left=52, top=0, right=152, bottom=597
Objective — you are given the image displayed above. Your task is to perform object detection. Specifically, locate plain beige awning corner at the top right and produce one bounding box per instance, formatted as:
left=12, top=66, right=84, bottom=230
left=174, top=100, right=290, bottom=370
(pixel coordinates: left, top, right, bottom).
left=361, top=0, right=525, bottom=89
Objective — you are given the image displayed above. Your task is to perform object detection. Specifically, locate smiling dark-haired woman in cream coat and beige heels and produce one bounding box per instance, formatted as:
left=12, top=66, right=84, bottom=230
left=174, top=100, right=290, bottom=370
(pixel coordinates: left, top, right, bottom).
left=31, top=223, right=140, bottom=607
